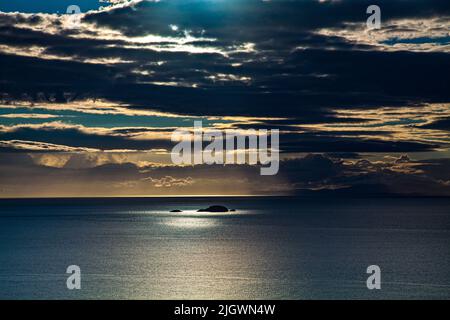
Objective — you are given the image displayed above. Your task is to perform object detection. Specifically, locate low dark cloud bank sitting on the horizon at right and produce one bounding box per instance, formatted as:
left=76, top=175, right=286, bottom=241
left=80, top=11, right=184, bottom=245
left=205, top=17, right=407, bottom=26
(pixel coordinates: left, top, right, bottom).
left=280, top=155, right=450, bottom=196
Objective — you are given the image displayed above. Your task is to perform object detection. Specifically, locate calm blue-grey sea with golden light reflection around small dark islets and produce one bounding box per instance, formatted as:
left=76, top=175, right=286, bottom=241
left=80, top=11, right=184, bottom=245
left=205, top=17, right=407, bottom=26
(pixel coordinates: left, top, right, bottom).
left=0, top=198, right=450, bottom=299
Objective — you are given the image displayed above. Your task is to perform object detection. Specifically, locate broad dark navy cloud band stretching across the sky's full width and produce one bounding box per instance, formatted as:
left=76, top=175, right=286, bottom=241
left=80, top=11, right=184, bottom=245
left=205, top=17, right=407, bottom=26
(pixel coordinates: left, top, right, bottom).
left=1, top=44, right=450, bottom=119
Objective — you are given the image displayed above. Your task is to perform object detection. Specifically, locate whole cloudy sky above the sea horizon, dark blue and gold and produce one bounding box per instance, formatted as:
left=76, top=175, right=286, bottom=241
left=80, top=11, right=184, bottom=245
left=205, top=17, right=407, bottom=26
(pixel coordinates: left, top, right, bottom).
left=0, top=0, right=450, bottom=197
